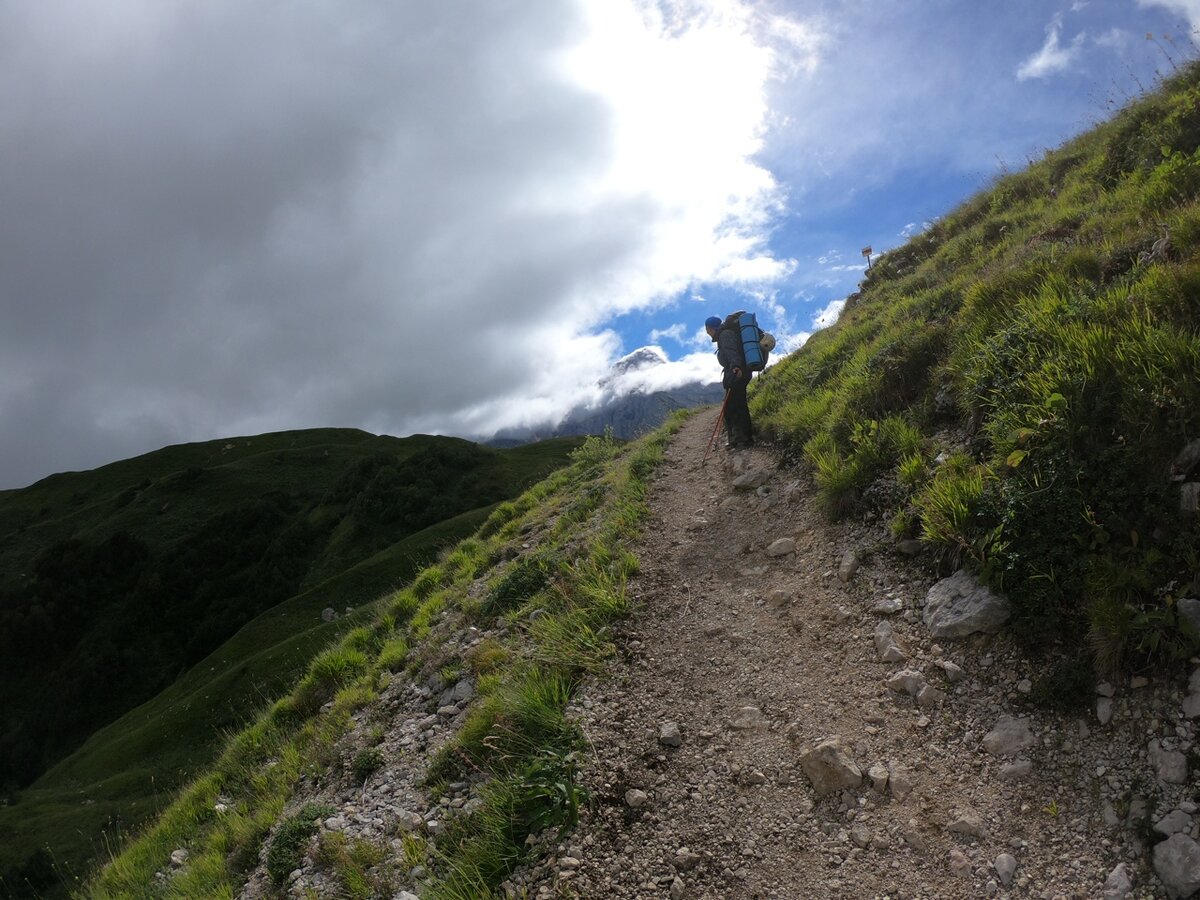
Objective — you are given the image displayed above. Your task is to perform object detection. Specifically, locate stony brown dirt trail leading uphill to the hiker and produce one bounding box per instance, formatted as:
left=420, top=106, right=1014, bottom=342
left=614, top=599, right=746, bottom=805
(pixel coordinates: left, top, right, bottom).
left=509, top=415, right=1200, bottom=900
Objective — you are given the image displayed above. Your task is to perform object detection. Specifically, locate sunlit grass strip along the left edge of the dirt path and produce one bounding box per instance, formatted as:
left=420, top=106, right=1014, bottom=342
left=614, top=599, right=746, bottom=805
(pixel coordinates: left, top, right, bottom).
left=84, top=425, right=674, bottom=898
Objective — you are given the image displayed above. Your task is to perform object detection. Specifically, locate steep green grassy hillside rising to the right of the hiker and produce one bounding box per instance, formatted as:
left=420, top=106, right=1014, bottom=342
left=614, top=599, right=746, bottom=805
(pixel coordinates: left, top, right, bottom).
left=754, top=66, right=1200, bottom=668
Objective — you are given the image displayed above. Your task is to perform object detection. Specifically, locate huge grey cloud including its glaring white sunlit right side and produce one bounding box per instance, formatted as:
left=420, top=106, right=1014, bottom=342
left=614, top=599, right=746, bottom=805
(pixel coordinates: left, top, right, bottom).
left=0, top=0, right=823, bottom=486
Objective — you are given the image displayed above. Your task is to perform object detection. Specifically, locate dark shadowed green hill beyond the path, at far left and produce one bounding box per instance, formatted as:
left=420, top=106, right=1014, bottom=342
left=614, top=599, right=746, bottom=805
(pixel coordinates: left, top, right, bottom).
left=0, top=430, right=580, bottom=897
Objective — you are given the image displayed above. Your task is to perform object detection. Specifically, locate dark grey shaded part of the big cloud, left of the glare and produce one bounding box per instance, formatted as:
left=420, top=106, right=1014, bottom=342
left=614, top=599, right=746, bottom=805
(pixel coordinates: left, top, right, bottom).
left=0, top=0, right=638, bottom=486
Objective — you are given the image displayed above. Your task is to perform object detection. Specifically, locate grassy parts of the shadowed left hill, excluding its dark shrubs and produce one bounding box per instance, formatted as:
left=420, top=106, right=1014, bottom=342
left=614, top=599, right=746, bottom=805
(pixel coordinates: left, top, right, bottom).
left=0, top=430, right=581, bottom=897
